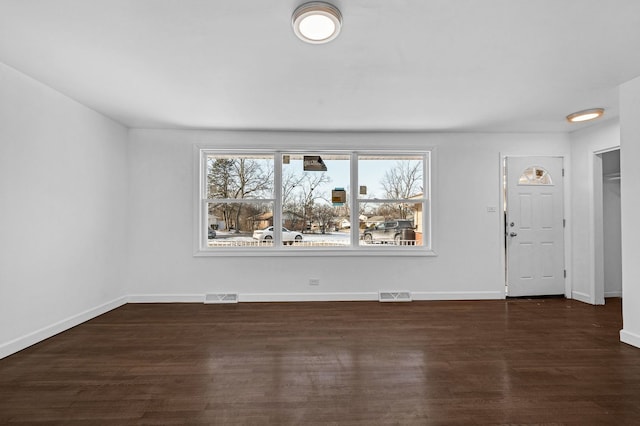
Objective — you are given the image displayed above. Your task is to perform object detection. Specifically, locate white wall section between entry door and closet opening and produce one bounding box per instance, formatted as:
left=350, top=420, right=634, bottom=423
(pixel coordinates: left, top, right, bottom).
left=569, top=120, right=620, bottom=304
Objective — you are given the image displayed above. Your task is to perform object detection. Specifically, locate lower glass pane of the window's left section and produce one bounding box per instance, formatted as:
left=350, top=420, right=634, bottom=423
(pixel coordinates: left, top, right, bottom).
left=207, top=202, right=274, bottom=247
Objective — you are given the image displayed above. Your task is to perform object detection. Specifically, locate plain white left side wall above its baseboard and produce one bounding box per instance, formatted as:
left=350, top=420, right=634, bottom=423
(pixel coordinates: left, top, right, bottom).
left=0, top=64, right=127, bottom=358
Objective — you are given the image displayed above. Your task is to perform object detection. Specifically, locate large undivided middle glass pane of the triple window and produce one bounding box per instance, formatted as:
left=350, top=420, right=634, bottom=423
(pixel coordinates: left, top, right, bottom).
left=282, top=153, right=351, bottom=247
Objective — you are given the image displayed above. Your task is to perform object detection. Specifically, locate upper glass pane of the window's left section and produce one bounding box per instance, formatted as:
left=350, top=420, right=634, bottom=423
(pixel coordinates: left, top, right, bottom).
left=205, top=154, right=274, bottom=199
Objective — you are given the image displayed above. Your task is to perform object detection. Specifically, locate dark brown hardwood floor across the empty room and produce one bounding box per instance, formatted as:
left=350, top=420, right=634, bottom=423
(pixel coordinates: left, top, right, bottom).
left=0, top=299, right=640, bottom=425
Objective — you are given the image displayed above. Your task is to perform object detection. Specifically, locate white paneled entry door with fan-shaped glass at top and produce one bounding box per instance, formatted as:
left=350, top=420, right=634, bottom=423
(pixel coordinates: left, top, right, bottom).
left=505, top=157, right=565, bottom=296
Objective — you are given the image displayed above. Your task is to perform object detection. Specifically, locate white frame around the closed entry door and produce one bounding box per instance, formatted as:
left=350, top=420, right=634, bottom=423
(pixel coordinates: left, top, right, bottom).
left=499, top=152, right=572, bottom=299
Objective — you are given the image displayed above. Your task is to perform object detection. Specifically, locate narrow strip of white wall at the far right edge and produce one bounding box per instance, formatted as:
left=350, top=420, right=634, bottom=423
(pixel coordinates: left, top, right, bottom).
left=620, top=78, right=640, bottom=347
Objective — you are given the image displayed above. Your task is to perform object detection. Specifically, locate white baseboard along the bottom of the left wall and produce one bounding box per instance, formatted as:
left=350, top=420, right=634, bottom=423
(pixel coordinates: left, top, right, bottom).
left=0, top=297, right=127, bottom=359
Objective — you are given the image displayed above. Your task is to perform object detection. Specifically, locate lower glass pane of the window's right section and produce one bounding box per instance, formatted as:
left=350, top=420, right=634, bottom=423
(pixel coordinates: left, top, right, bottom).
left=359, top=201, right=427, bottom=247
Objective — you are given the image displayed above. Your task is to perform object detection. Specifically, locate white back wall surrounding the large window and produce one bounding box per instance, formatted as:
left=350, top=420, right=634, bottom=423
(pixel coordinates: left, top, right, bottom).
left=128, top=130, right=570, bottom=301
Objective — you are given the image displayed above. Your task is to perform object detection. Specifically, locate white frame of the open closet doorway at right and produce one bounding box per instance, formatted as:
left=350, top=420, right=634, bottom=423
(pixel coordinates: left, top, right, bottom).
left=590, top=145, right=620, bottom=305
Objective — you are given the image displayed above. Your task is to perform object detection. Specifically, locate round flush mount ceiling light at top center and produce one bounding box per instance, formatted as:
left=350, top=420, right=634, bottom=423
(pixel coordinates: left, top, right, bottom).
left=291, top=1, right=342, bottom=44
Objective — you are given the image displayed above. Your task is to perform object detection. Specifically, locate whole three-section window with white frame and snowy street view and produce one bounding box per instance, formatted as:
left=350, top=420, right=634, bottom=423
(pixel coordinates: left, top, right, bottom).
left=195, top=148, right=433, bottom=256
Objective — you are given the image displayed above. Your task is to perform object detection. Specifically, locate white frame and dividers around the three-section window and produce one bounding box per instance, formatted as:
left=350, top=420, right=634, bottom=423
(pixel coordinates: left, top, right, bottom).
left=193, top=147, right=437, bottom=257
